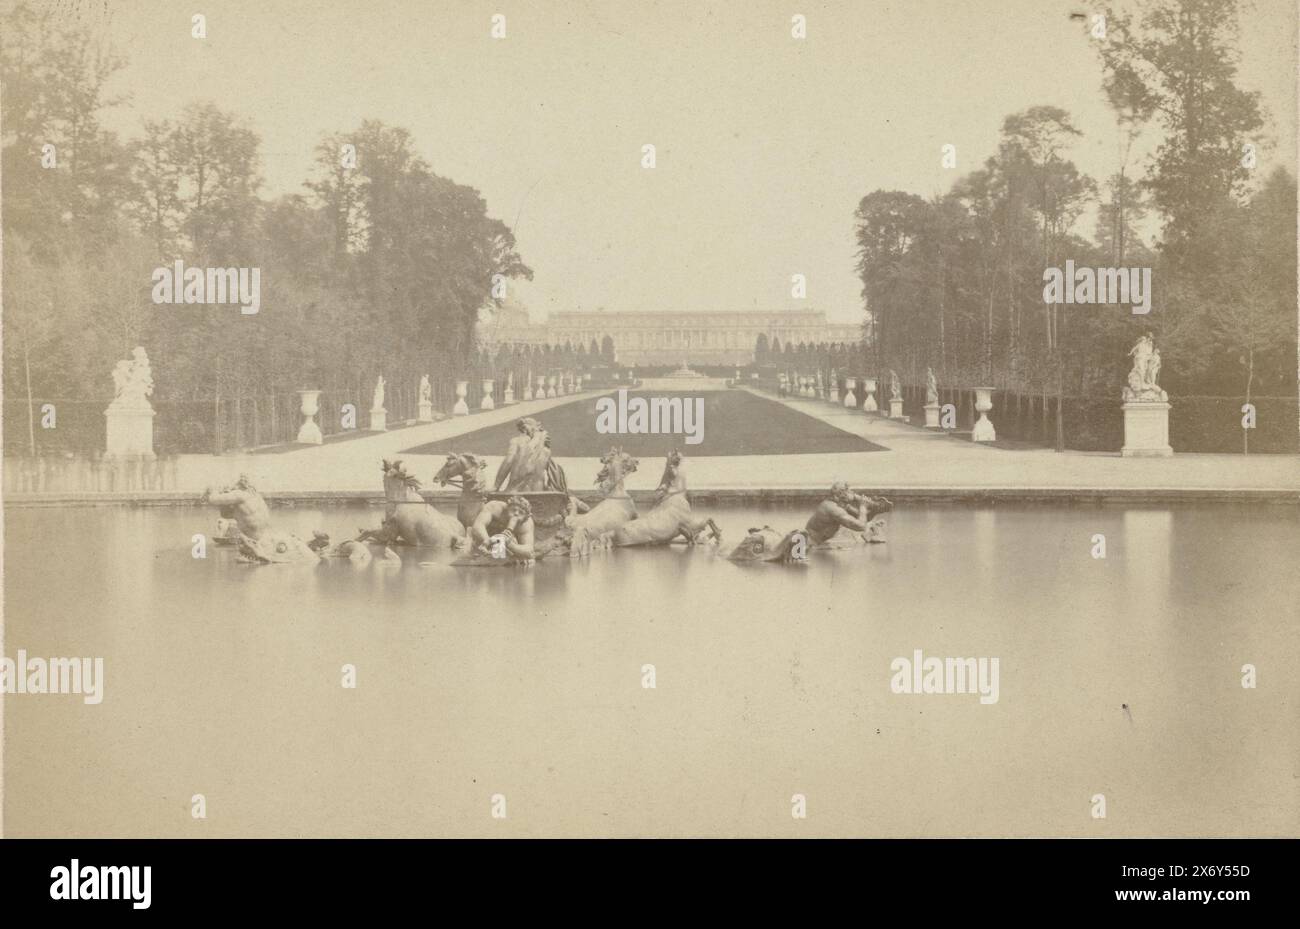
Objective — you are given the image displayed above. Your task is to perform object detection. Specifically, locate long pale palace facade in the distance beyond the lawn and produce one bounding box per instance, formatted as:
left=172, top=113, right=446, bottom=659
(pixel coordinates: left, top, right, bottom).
left=480, top=304, right=862, bottom=365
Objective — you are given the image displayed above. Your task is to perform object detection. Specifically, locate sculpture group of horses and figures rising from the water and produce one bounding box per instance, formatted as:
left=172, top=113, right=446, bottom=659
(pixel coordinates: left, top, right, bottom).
left=202, top=417, right=892, bottom=568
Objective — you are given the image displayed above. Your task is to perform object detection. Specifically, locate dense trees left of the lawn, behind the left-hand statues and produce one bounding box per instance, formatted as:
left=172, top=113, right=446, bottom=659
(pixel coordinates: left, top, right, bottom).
left=0, top=4, right=532, bottom=436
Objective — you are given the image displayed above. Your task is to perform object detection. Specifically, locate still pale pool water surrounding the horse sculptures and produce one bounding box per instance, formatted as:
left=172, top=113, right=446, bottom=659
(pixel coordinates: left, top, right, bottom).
left=4, top=505, right=1300, bottom=837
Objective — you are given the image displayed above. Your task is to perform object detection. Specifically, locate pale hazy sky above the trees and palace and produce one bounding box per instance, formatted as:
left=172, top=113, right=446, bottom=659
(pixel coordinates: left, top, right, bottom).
left=61, top=0, right=1296, bottom=321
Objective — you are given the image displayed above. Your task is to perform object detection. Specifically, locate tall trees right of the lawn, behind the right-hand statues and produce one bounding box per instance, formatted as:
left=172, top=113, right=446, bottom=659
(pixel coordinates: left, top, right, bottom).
left=855, top=0, right=1296, bottom=447
